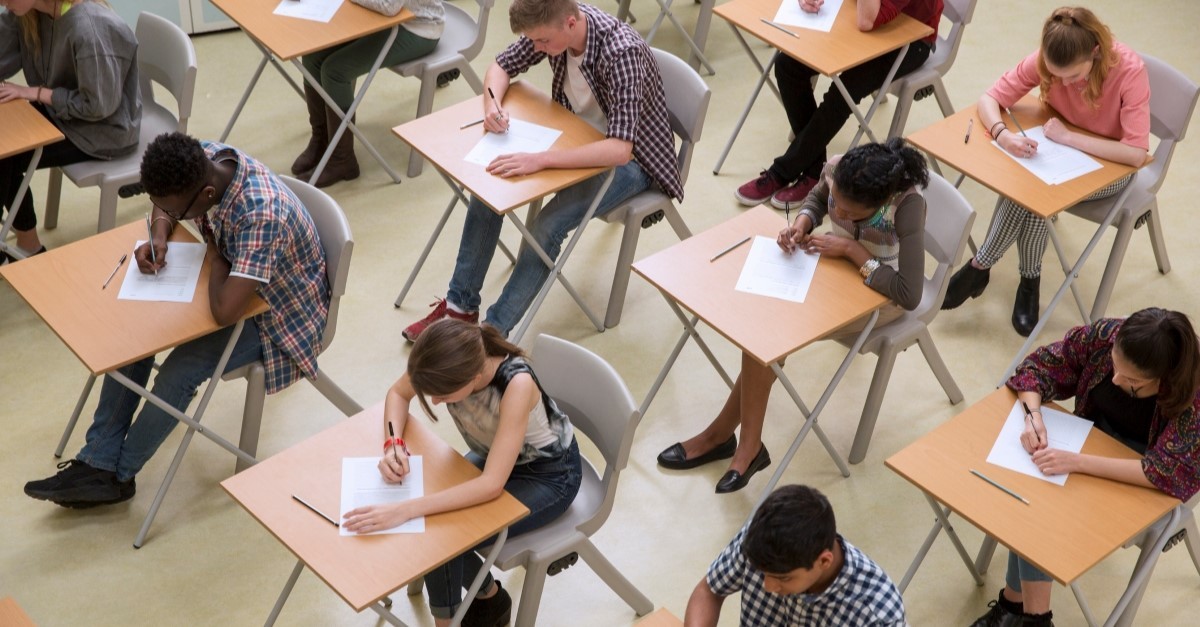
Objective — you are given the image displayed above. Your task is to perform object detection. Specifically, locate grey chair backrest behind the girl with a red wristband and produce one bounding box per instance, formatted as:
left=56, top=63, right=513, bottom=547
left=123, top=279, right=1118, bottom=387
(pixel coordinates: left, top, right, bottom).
left=532, top=335, right=642, bottom=535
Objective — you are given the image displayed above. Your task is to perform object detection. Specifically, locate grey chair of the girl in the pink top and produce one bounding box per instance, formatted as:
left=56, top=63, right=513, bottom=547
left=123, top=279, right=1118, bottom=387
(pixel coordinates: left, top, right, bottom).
left=1068, top=54, right=1200, bottom=320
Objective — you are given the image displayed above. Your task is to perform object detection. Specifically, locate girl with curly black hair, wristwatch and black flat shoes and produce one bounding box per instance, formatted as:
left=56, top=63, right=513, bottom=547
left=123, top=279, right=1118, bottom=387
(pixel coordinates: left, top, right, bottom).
left=658, top=138, right=929, bottom=494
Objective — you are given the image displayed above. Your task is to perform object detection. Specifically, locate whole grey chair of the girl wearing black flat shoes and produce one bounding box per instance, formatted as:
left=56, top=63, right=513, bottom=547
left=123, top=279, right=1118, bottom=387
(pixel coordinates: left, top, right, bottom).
left=841, top=172, right=976, bottom=464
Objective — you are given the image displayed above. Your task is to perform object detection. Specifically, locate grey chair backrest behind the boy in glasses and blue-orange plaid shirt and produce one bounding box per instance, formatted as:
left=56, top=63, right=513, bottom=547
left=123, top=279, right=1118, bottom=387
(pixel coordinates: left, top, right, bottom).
left=280, top=177, right=354, bottom=352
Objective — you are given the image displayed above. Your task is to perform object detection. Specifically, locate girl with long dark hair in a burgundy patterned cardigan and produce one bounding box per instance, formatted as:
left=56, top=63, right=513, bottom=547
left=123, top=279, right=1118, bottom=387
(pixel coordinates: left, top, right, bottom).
left=974, top=307, right=1200, bottom=627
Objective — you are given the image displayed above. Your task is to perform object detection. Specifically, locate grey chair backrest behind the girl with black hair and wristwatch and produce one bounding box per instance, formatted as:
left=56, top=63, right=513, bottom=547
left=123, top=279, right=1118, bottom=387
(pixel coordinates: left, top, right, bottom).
left=913, top=172, right=976, bottom=324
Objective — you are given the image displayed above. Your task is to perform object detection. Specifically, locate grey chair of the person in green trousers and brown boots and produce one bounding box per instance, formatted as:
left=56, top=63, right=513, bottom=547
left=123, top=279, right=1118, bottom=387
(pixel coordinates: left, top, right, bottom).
left=390, top=0, right=496, bottom=178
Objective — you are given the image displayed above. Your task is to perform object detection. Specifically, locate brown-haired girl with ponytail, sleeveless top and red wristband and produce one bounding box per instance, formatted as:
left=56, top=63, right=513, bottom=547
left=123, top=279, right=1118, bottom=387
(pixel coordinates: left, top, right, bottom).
left=344, top=318, right=582, bottom=627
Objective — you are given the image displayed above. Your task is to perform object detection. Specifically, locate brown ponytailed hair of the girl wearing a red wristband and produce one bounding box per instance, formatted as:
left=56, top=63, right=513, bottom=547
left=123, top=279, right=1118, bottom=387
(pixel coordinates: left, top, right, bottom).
left=407, top=318, right=524, bottom=420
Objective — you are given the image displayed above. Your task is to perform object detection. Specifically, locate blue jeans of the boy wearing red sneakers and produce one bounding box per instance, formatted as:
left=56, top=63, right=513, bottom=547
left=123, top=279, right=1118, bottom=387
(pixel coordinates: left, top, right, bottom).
left=446, top=161, right=650, bottom=335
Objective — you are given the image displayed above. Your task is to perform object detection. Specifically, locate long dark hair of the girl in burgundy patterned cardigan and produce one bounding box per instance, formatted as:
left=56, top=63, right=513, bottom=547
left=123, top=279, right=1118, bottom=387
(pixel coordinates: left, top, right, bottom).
left=1116, top=307, right=1200, bottom=419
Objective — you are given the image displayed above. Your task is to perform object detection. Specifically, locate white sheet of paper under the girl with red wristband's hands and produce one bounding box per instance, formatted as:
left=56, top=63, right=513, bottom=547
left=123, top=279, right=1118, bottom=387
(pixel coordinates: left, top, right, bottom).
left=338, top=455, right=425, bottom=536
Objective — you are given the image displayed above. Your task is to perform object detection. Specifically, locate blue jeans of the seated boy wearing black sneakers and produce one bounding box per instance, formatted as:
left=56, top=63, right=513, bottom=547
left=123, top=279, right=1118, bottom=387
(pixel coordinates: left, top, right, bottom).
left=77, top=318, right=263, bottom=482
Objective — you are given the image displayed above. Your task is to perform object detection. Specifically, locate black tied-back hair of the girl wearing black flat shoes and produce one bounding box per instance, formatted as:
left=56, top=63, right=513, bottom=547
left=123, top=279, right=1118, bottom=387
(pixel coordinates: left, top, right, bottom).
left=833, top=137, right=929, bottom=207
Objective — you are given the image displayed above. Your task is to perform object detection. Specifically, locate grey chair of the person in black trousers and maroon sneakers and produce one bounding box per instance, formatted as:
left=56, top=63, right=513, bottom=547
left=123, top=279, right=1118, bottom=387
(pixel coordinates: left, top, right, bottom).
left=888, top=0, right=978, bottom=137
